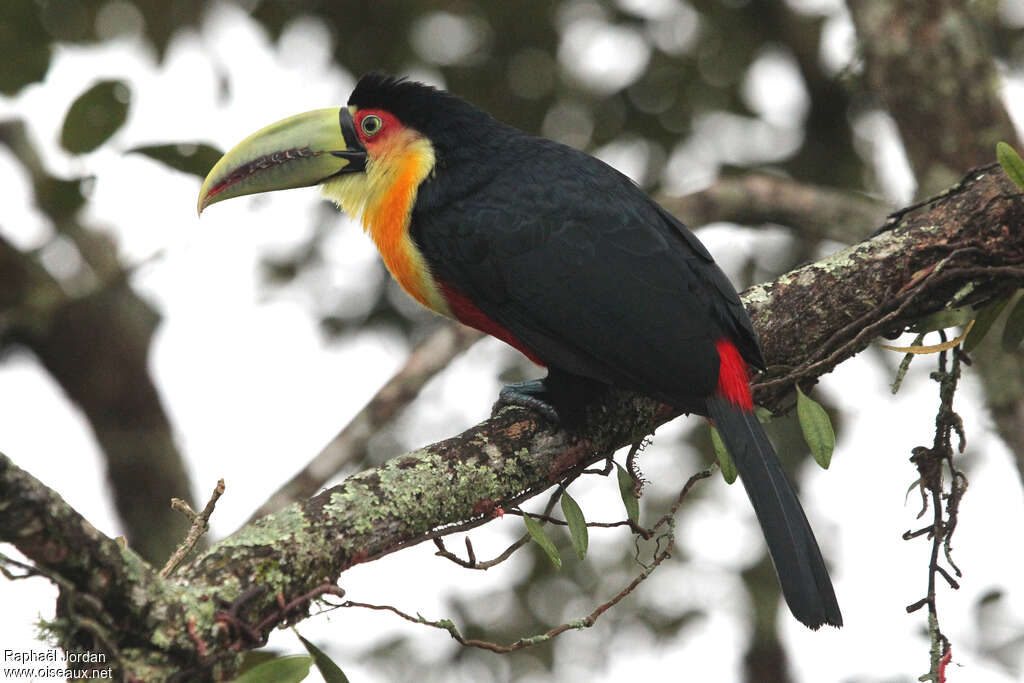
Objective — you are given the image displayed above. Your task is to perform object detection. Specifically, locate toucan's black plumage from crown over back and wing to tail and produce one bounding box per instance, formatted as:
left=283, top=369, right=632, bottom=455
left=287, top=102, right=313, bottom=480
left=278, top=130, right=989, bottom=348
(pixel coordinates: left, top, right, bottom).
left=349, top=75, right=842, bottom=628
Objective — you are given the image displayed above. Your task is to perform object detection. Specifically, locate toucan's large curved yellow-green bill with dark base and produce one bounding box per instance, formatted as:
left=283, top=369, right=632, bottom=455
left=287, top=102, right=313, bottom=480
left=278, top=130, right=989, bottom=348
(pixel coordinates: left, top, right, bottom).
left=199, top=106, right=367, bottom=213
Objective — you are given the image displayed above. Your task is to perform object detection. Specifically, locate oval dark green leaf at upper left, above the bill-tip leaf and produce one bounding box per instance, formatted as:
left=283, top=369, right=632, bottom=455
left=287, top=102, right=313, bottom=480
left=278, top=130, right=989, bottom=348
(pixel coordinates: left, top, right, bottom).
left=60, top=81, right=131, bottom=155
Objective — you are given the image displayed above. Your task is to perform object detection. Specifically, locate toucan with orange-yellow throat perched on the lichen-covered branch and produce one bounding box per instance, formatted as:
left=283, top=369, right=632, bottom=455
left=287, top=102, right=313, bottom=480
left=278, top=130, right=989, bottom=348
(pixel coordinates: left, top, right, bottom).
left=199, top=74, right=843, bottom=629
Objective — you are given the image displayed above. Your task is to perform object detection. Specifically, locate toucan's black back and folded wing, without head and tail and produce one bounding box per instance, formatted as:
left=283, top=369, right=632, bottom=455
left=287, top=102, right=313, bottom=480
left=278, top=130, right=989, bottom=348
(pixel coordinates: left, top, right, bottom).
left=411, top=121, right=764, bottom=414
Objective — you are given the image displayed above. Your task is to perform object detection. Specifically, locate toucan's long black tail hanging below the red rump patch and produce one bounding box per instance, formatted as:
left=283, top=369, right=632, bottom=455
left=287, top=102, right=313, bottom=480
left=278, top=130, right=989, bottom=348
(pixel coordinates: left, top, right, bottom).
left=708, top=395, right=843, bottom=629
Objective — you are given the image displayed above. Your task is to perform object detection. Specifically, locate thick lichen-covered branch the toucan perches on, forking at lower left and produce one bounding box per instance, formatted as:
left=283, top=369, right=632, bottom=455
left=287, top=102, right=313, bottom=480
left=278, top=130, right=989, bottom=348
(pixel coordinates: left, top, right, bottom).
left=0, top=168, right=1024, bottom=680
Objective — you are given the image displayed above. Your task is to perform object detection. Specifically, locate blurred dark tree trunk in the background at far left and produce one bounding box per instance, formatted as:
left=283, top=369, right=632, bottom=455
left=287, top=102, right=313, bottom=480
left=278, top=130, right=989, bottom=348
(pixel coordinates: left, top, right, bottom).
left=0, top=121, right=191, bottom=562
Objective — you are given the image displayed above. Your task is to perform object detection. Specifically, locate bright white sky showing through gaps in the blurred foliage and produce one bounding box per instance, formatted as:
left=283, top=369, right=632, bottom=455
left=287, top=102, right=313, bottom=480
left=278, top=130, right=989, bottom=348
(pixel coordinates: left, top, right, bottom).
left=0, top=2, right=1024, bottom=683
